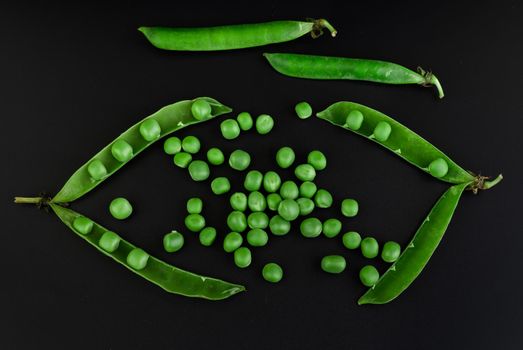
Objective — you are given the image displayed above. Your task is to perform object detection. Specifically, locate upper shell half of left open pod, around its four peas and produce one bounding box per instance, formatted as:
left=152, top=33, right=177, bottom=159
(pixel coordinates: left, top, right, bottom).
left=51, top=97, right=231, bottom=203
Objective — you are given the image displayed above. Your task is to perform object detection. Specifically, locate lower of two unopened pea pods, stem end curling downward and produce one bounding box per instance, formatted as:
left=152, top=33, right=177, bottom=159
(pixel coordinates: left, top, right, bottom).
left=263, top=53, right=445, bottom=98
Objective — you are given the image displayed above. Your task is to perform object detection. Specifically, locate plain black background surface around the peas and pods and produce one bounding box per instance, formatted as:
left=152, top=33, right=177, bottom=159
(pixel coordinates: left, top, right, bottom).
left=0, top=1, right=523, bottom=349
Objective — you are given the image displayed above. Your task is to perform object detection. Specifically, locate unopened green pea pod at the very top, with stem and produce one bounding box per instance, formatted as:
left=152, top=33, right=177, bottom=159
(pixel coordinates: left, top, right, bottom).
left=138, top=19, right=336, bottom=51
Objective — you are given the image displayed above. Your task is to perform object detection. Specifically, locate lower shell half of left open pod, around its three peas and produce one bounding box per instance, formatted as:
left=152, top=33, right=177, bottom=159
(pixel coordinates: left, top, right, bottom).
left=50, top=203, right=245, bottom=300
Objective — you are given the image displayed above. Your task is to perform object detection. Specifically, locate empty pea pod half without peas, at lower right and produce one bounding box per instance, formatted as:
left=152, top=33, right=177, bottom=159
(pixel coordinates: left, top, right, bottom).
left=358, top=183, right=470, bottom=305
